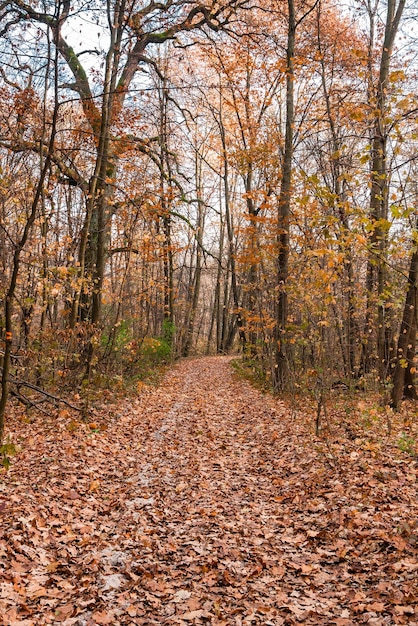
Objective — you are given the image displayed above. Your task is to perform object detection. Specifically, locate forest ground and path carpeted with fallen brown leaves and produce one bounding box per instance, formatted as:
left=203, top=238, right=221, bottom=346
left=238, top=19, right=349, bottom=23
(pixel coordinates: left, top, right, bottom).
left=0, top=357, right=418, bottom=626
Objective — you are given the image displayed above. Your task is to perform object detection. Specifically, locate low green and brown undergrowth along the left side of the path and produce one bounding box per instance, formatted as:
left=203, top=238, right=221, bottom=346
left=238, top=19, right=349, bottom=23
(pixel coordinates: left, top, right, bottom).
left=0, top=322, right=174, bottom=426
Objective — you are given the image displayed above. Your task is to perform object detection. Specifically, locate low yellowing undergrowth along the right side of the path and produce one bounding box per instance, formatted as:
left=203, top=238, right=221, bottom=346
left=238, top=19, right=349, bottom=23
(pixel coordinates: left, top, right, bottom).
left=231, top=359, right=418, bottom=459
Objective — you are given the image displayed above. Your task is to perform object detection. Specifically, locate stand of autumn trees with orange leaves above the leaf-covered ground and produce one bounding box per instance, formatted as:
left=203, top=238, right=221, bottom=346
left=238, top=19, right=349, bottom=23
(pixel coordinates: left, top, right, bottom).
left=0, top=0, right=416, bottom=406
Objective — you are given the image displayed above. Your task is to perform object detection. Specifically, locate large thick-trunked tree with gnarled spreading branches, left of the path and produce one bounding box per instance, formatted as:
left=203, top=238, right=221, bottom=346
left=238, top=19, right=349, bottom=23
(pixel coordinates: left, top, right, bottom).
left=3, top=0, right=251, bottom=324
